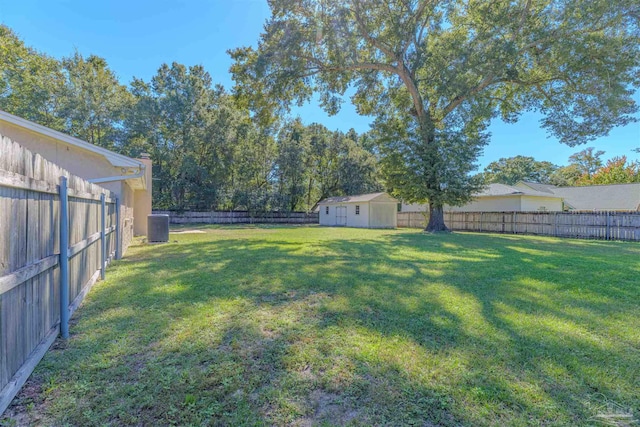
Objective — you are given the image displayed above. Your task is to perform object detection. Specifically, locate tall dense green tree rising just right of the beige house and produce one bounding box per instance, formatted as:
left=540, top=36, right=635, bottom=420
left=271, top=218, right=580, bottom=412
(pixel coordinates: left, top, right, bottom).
left=126, top=63, right=249, bottom=209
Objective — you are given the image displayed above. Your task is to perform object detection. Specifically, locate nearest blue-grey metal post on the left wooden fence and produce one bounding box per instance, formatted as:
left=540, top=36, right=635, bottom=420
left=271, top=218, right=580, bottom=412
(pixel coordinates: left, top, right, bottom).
left=60, top=176, right=69, bottom=339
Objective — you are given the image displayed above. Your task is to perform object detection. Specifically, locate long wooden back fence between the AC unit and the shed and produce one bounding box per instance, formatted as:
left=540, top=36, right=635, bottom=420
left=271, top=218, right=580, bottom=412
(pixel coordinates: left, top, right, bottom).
left=153, top=211, right=319, bottom=224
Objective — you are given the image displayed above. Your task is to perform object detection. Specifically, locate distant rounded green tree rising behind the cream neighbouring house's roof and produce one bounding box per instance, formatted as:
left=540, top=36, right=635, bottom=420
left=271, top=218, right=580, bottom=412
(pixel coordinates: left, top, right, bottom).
left=482, top=156, right=558, bottom=185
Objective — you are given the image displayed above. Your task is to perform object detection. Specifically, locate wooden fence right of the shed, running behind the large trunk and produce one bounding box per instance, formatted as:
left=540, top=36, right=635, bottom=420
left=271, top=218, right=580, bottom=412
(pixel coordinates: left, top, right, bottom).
left=398, top=211, right=640, bottom=241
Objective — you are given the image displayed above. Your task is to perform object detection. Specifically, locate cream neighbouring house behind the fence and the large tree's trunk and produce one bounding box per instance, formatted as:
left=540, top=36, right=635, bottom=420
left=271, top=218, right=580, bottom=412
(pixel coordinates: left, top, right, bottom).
left=401, top=184, right=562, bottom=212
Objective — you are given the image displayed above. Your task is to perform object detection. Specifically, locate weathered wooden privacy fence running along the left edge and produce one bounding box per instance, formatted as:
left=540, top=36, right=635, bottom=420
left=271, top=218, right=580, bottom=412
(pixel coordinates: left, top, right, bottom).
left=0, top=135, right=121, bottom=414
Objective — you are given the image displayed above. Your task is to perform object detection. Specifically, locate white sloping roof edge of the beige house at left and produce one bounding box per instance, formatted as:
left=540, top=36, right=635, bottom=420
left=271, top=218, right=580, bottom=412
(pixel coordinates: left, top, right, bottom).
left=0, top=110, right=144, bottom=169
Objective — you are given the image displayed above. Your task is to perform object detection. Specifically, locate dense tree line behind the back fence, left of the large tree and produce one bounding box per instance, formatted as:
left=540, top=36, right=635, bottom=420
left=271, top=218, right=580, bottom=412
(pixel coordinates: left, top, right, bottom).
left=0, top=26, right=382, bottom=211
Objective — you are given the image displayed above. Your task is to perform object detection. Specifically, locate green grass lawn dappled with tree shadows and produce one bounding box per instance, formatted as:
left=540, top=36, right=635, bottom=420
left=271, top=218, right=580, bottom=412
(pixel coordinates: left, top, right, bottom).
left=3, top=226, right=640, bottom=426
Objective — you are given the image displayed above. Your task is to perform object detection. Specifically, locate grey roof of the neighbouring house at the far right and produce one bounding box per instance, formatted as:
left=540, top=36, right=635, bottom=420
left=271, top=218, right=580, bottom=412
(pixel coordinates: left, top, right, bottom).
left=516, top=181, right=640, bottom=211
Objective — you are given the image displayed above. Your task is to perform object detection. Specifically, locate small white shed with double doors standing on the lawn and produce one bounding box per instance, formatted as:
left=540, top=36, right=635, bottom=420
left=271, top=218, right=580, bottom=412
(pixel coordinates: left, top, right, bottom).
left=318, top=193, right=398, bottom=228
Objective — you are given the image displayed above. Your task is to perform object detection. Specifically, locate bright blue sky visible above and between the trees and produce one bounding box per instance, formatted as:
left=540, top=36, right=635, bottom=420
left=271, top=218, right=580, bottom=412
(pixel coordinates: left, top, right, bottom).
left=0, top=0, right=640, bottom=171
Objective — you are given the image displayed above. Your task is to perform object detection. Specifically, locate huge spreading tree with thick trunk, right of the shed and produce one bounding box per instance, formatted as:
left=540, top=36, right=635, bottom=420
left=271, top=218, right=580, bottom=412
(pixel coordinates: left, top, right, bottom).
left=231, top=0, right=640, bottom=231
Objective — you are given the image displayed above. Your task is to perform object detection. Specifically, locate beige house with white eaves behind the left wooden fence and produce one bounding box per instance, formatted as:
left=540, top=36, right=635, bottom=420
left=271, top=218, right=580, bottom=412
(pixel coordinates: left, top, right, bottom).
left=0, top=110, right=151, bottom=247
